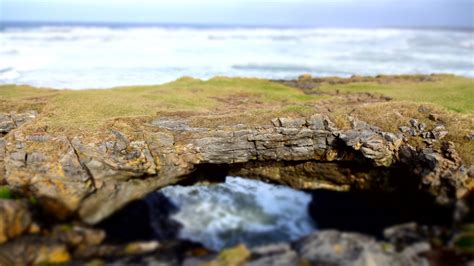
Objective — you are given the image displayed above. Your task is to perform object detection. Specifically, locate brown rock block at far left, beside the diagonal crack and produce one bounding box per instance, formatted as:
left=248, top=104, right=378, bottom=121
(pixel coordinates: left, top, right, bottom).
left=5, top=132, right=94, bottom=218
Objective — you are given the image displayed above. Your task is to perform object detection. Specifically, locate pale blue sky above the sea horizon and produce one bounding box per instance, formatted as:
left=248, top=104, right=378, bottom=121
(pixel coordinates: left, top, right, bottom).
left=0, top=0, right=474, bottom=28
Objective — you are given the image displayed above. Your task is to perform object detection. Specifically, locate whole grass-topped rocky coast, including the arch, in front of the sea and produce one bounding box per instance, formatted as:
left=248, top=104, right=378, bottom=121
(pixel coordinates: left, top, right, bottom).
left=0, top=75, right=474, bottom=265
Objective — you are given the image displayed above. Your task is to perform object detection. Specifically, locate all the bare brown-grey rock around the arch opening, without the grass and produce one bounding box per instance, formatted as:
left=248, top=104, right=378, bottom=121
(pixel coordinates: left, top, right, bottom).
left=0, top=76, right=474, bottom=265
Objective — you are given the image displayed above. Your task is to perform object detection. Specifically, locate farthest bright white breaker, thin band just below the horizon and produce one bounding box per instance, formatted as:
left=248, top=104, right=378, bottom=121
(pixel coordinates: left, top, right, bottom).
left=2, top=26, right=414, bottom=41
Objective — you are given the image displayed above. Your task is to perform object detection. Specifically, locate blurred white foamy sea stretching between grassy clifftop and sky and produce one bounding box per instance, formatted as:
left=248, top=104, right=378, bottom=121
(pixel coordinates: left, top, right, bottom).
left=0, top=22, right=474, bottom=89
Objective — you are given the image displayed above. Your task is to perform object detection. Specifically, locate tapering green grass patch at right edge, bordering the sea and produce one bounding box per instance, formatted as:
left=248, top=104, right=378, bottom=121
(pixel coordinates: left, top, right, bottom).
left=316, top=75, right=474, bottom=114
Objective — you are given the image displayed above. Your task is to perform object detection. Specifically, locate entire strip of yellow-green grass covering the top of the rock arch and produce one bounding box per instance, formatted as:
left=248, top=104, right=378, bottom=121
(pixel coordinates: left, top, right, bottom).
left=0, top=75, right=474, bottom=163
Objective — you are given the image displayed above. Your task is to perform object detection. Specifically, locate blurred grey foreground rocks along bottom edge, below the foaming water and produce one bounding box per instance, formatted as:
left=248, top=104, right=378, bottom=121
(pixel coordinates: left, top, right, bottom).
left=104, top=230, right=436, bottom=266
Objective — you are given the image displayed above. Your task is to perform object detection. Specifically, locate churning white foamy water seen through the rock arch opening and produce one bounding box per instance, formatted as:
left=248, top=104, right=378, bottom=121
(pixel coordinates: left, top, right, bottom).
left=161, top=177, right=315, bottom=250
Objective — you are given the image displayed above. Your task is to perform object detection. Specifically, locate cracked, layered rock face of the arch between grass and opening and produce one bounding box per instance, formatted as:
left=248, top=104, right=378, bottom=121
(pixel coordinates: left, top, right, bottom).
left=0, top=111, right=471, bottom=224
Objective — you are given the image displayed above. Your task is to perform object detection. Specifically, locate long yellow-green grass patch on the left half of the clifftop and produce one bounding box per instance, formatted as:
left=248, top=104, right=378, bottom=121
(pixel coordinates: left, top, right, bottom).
left=15, top=77, right=318, bottom=131
